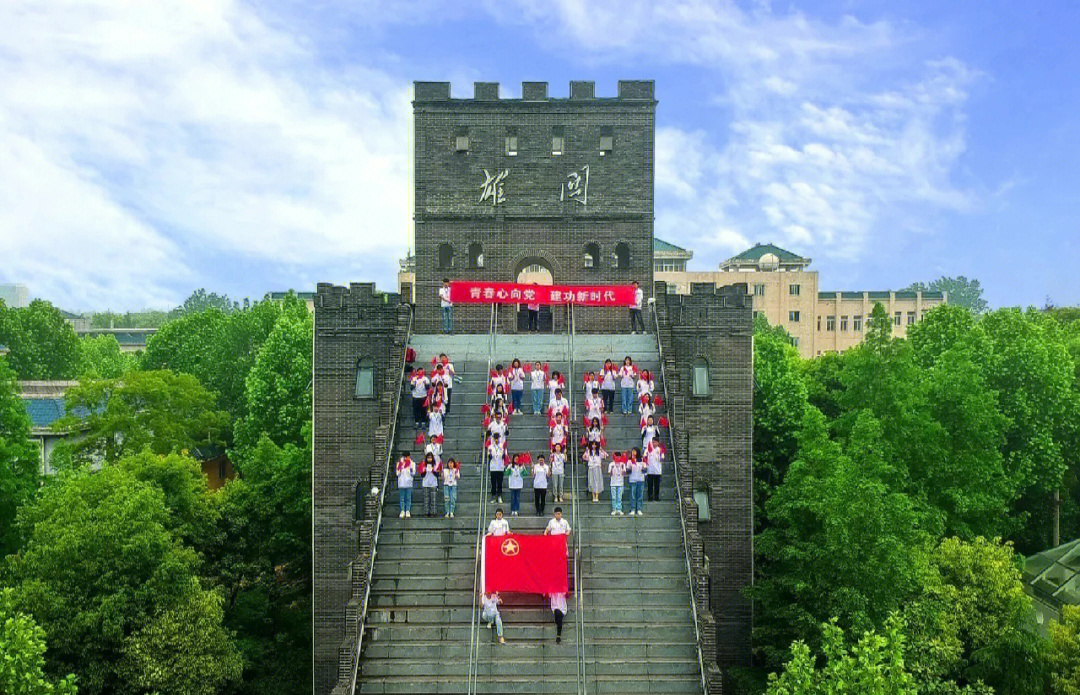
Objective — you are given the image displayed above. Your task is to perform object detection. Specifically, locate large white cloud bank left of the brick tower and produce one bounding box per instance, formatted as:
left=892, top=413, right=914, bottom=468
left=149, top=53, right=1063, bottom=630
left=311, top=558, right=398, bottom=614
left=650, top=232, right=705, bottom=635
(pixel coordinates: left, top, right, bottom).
left=0, top=0, right=411, bottom=308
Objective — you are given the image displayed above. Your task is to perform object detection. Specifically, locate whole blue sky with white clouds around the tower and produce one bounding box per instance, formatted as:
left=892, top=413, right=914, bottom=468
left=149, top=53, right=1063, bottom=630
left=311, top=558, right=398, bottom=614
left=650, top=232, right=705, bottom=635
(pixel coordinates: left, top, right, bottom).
left=0, top=0, right=1080, bottom=311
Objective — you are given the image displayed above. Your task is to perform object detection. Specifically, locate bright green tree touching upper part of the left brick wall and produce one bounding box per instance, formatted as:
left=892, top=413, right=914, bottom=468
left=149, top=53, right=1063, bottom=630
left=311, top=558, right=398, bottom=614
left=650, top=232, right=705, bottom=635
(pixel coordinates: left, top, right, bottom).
left=234, top=306, right=314, bottom=455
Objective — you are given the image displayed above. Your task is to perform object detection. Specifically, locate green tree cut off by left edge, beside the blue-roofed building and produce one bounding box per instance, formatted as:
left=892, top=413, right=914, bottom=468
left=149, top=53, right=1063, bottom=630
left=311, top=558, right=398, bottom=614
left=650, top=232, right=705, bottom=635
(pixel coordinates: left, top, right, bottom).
left=0, top=357, right=40, bottom=558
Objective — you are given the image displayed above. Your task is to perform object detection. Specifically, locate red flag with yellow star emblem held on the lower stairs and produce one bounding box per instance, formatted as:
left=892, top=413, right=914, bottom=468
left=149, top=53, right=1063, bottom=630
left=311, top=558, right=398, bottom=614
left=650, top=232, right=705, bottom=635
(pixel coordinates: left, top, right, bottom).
left=484, top=533, right=569, bottom=594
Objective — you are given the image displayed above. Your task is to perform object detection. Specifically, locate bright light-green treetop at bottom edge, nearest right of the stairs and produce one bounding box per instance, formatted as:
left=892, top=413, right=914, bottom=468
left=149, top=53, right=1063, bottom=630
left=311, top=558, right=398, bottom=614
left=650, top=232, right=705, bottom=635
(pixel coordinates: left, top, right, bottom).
left=767, top=617, right=919, bottom=695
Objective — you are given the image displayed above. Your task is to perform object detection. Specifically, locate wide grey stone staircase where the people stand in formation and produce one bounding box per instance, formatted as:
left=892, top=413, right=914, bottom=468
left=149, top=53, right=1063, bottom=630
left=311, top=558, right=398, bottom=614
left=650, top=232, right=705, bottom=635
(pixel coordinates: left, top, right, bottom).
left=357, top=335, right=701, bottom=695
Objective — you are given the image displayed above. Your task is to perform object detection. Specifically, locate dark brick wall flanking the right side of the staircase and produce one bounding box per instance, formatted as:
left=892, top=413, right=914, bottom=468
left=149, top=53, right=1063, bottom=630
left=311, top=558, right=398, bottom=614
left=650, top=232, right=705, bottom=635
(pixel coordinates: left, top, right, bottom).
left=656, top=283, right=754, bottom=667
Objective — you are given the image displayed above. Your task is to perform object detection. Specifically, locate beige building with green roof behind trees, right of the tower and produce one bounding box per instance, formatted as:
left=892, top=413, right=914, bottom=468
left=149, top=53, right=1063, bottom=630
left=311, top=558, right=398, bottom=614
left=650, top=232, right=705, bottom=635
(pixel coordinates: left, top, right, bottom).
left=656, top=240, right=948, bottom=357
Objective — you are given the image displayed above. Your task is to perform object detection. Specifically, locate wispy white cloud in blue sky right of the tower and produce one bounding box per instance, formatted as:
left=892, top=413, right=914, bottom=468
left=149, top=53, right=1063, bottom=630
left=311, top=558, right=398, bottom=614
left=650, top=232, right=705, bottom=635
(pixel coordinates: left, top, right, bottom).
left=496, top=0, right=978, bottom=267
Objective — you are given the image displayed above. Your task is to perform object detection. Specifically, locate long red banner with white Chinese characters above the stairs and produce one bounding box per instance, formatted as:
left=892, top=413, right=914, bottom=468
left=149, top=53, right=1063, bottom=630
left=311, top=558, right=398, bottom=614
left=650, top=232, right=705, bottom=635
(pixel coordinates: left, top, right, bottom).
left=450, top=280, right=634, bottom=306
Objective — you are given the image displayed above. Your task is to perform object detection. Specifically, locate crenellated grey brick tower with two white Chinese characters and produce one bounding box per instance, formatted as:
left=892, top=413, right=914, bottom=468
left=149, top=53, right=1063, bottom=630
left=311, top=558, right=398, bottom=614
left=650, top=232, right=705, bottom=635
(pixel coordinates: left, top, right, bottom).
left=413, top=80, right=657, bottom=332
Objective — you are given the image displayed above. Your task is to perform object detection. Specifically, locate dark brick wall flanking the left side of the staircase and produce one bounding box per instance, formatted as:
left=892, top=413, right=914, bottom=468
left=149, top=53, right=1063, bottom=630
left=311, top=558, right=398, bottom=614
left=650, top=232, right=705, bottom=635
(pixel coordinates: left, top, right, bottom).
left=312, top=283, right=410, bottom=695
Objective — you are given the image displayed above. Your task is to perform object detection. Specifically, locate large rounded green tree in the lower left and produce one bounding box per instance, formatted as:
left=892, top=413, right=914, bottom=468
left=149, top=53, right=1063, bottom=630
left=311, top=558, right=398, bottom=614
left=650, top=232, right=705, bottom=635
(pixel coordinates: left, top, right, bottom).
left=10, top=466, right=239, bottom=694
